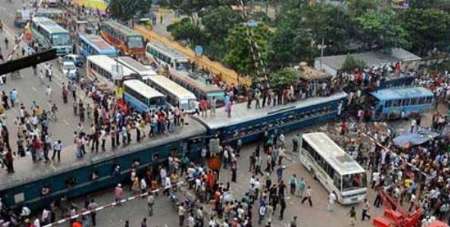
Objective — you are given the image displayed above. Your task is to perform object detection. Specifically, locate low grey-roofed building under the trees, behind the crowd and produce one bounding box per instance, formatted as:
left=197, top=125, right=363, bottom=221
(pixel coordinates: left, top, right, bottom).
left=314, top=48, right=421, bottom=76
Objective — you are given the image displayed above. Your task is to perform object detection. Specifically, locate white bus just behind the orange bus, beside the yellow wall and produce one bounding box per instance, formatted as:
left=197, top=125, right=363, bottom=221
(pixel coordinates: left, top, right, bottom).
left=145, top=42, right=189, bottom=71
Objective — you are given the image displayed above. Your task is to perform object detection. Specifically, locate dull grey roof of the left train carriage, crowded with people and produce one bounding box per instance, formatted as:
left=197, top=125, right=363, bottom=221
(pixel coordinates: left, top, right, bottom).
left=0, top=117, right=206, bottom=192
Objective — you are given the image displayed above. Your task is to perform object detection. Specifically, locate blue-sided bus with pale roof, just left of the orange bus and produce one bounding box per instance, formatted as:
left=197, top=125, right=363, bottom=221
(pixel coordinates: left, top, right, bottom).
left=78, top=33, right=117, bottom=58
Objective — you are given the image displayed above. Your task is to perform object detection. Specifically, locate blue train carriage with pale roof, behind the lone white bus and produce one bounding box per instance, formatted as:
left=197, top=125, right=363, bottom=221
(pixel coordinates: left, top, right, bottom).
left=195, top=92, right=347, bottom=144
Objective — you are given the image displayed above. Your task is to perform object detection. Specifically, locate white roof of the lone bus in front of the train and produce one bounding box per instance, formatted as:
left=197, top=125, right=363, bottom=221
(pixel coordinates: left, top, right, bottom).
left=303, top=132, right=365, bottom=175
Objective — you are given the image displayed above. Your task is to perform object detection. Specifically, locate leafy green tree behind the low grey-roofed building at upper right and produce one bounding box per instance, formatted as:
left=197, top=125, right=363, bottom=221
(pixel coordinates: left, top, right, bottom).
left=355, top=9, right=410, bottom=49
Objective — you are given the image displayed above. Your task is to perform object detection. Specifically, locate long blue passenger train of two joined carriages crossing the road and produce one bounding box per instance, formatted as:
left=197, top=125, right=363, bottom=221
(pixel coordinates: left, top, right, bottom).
left=0, top=92, right=347, bottom=210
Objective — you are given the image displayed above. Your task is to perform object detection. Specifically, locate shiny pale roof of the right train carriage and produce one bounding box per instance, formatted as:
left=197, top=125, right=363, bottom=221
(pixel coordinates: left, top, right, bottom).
left=195, top=92, right=347, bottom=129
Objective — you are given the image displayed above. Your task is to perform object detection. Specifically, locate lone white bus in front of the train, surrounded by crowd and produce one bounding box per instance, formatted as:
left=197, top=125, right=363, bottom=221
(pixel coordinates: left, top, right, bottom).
left=300, top=132, right=367, bottom=204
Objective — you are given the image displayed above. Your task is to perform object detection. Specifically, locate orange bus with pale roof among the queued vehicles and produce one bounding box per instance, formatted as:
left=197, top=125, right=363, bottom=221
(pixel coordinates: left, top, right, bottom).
left=100, top=20, right=145, bottom=57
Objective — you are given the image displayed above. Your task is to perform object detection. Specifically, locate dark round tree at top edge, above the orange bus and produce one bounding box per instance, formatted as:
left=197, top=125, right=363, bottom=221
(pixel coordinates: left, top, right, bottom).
left=107, top=0, right=152, bottom=21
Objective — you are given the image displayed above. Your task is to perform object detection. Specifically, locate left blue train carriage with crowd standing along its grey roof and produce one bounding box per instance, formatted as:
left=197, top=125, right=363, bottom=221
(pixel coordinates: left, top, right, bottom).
left=0, top=119, right=206, bottom=210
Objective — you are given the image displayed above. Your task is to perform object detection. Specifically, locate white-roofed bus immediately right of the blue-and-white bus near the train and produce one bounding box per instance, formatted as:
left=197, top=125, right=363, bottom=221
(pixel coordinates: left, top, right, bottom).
left=144, top=75, right=197, bottom=112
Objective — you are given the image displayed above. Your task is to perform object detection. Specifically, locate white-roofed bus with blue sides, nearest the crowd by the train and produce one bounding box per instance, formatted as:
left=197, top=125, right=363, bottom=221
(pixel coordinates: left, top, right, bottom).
left=123, top=80, right=166, bottom=113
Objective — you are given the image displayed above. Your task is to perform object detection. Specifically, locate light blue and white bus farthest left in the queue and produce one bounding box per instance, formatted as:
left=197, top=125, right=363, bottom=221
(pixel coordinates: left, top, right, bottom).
left=31, top=17, right=72, bottom=56
